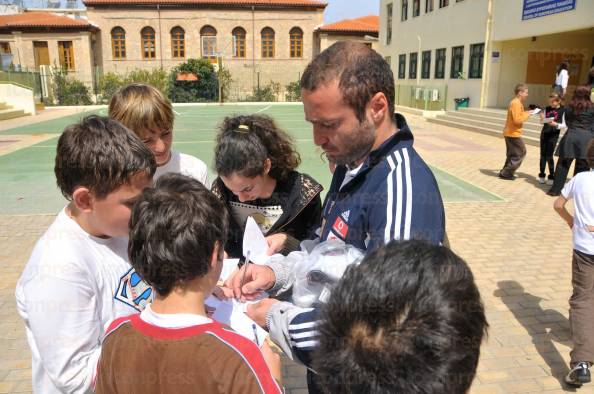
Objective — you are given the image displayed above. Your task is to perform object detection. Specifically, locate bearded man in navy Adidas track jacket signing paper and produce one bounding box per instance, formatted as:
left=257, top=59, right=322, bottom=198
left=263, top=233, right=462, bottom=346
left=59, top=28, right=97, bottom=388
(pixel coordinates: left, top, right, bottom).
left=228, top=42, right=445, bottom=390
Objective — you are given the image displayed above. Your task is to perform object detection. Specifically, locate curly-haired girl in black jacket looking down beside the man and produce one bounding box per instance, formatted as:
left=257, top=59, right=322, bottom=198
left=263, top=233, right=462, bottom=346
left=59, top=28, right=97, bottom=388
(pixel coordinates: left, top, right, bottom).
left=212, top=115, right=322, bottom=258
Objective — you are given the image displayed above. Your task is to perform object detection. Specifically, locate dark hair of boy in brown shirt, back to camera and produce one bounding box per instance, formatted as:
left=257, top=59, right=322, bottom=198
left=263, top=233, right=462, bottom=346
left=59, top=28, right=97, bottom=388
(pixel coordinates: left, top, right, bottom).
left=128, top=174, right=227, bottom=296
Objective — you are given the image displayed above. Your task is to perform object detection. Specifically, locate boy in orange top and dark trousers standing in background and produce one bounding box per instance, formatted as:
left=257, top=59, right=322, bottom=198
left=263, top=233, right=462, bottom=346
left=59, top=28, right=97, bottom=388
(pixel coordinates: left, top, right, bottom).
left=499, top=83, right=534, bottom=180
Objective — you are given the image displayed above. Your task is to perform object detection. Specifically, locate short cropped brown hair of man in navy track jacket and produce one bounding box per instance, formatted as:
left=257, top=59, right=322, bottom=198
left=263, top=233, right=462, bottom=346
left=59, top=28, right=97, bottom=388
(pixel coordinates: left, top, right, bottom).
left=301, top=41, right=395, bottom=122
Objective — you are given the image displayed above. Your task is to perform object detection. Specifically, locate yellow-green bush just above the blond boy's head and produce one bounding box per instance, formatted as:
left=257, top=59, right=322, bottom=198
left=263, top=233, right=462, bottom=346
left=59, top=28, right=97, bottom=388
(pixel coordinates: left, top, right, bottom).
left=97, top=68, right=169, bottom=103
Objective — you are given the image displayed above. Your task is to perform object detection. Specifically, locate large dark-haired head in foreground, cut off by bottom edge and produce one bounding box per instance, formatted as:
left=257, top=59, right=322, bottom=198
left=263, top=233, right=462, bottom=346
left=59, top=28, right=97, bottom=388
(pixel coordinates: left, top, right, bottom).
left=314, top=241, right=488, bottom=394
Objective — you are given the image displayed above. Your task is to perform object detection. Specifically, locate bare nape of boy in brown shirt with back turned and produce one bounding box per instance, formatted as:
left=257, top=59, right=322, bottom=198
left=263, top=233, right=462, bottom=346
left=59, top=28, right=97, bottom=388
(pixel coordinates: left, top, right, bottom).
left=151, top=278, right=212, bottom=316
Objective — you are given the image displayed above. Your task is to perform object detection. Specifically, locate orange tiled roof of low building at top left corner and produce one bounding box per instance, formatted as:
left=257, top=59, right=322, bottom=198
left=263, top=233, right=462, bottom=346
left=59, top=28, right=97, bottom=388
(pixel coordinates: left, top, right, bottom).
left=0, top=12, right=94, bottom=30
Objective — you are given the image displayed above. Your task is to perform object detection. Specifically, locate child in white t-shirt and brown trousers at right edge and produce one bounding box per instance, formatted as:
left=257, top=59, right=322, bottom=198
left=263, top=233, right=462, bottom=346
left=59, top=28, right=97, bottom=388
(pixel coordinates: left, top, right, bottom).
left=554, top=141, right=594, bottom=386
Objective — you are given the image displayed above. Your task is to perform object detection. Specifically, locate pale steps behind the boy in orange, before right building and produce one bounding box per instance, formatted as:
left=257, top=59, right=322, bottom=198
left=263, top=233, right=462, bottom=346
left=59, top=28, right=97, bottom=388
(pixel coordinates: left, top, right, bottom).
left=427, top=108, right=542, bottom=146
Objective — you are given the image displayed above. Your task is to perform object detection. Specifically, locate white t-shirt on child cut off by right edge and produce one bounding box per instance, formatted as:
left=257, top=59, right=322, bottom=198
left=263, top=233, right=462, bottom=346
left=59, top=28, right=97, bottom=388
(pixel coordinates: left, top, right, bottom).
left=561, top=171, right=594, bottom=255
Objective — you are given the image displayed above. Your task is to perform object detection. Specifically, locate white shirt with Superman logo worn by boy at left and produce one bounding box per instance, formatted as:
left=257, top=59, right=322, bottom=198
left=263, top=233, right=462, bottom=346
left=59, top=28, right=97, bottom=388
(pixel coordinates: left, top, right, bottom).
left=16, top=210, right=152, bottom=393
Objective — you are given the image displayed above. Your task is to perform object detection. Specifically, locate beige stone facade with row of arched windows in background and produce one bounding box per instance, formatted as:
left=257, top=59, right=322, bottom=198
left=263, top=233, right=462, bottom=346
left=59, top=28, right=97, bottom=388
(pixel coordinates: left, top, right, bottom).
left=85, top=0, right=325, bottom=99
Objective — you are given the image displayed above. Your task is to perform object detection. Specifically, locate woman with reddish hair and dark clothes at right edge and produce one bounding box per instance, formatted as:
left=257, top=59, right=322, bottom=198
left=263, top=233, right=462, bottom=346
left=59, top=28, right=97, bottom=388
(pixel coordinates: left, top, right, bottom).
left=547, top=85, right=594, bottom=196
